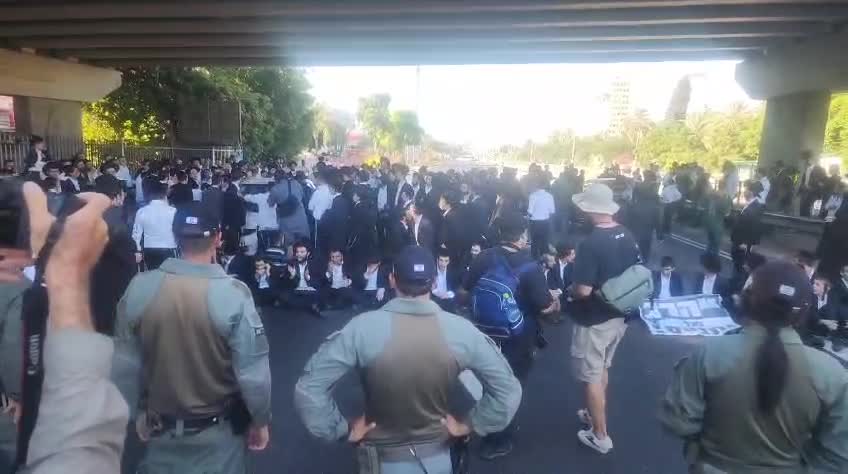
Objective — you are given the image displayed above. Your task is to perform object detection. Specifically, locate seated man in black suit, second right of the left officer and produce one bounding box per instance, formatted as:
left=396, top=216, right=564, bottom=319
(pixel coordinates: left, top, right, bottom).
left=282, top=242, right=325, bottom=318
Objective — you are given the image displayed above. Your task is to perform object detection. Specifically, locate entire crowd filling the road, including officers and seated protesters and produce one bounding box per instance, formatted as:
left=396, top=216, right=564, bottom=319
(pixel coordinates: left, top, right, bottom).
left=0, top=134, right=848, bottom=474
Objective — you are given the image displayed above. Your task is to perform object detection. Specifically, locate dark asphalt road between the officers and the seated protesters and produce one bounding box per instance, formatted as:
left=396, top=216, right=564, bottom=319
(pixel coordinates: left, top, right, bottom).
left=248, top=239, right=712, bottom=474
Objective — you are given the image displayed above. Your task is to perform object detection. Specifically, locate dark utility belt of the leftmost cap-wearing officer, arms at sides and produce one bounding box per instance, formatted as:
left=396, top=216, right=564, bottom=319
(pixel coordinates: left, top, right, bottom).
left=144, top=398, right=252, bottom=437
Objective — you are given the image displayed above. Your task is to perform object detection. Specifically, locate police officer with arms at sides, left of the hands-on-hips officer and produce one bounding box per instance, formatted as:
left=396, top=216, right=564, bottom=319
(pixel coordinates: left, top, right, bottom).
left=113, top=203, right=271, bottom=474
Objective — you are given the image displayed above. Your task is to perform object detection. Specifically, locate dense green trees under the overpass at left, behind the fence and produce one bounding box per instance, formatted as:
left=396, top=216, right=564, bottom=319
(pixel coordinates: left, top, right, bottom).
left=83, top=67, right=313, bottom=158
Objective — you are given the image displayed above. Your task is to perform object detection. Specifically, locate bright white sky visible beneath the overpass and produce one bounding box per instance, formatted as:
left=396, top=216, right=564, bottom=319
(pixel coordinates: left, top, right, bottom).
left=306, top=61, right=755, bottom=150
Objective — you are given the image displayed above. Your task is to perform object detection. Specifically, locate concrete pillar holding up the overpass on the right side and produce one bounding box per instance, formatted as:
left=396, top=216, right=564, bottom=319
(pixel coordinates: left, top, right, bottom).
left=759, top=91, right=830, bottom=168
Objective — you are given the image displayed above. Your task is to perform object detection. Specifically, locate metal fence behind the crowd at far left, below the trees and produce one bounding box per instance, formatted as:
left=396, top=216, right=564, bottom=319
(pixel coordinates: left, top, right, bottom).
left=0, top=133, right=241, bottom=172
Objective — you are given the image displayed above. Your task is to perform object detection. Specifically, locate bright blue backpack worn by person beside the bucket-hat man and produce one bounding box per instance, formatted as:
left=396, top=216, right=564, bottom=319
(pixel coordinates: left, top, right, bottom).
left=471, top=254, right=537, bottom=340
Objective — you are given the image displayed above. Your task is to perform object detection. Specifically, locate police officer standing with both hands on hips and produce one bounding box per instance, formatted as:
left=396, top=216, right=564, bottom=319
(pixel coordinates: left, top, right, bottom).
left=294, top=246, right=521, bottom=474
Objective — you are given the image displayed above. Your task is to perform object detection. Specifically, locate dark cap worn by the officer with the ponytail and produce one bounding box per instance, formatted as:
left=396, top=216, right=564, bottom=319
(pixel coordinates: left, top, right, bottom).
left=748, top=260, right=813, bottom=310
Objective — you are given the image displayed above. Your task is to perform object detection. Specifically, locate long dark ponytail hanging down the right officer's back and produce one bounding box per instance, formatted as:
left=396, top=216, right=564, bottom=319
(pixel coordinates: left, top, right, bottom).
left=755, top=323, right=789, bottom=415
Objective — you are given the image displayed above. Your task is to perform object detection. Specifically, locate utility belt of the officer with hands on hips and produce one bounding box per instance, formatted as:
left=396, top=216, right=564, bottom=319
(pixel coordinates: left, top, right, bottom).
left=356, top=437, right=470, bottom=474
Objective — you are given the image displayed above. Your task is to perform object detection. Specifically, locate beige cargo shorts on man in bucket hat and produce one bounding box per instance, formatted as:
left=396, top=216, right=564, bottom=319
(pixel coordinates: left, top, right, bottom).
left=571, top=318, right=627, bottom=383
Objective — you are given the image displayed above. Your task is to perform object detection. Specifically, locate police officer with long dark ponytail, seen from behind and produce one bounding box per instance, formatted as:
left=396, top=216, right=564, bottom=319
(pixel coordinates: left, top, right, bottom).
left=660, top=262, right=848, bottom=474
